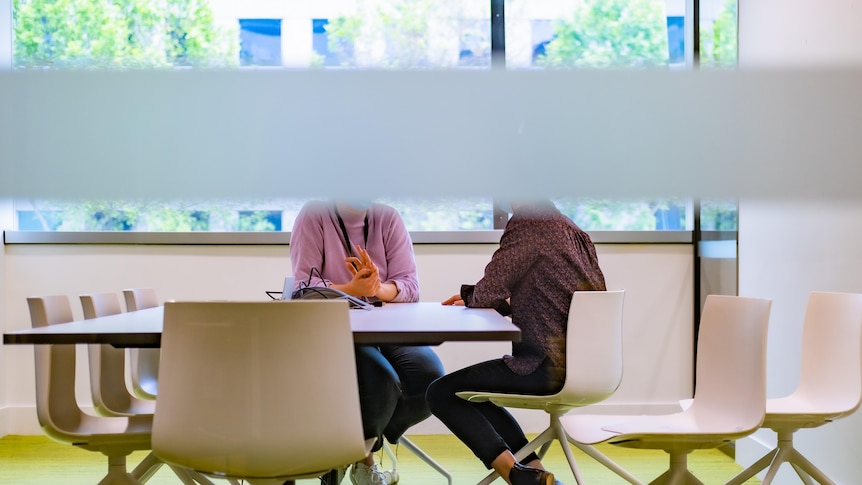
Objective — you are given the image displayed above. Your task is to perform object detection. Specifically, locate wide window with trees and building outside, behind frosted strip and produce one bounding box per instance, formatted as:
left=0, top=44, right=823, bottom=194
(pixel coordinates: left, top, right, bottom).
left=0, top=0, right=737, bottom=231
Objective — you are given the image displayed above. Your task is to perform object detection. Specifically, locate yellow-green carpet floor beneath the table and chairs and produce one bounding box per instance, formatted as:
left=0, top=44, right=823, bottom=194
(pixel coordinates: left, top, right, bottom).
left=0, top=435, right=760, bottom=485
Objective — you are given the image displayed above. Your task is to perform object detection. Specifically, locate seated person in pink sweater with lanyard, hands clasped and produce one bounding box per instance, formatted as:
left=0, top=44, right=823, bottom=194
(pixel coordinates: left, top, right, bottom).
left=290, top=200, right=443, bottom=485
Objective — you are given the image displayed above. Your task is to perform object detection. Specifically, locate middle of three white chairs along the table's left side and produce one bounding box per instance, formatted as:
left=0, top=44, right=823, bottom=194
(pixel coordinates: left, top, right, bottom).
left=80, top=293, right=156, bottom=416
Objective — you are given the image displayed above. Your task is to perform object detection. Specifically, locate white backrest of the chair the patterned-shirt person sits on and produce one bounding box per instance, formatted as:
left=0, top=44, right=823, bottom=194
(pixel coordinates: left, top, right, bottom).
left=558, top=290, right=625, bottom=406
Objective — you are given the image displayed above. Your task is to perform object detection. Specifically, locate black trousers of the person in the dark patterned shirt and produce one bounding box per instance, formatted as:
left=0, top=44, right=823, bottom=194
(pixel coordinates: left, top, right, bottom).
left=426, top=358, right=564, bottom=469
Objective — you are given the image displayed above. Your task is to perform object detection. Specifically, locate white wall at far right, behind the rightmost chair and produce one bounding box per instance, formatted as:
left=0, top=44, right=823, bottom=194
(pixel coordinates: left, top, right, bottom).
left=737, top=0, right=862, bottom=484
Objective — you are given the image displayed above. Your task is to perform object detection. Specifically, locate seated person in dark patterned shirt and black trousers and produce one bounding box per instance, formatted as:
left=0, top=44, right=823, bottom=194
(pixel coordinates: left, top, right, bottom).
left=426, top=200, right=606, bottom=485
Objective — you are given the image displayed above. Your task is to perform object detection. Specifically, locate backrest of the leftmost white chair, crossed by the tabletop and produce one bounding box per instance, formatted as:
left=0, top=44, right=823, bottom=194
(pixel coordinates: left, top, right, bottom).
left=27, top=295, right=83, bottom=439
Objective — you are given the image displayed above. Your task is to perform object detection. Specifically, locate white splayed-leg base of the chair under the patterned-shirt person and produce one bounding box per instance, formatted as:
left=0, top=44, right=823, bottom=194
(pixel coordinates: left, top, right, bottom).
left=472, top=416, right=643, bottom=485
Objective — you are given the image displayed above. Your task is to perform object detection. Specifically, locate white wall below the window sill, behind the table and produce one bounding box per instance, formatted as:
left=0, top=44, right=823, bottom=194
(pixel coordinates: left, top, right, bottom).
left=0, top=244, right=693, bottom=436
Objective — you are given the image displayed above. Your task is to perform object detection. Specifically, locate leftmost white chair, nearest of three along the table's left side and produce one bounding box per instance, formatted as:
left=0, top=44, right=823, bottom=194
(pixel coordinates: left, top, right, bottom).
left=27, top=295, right=155, bottom=485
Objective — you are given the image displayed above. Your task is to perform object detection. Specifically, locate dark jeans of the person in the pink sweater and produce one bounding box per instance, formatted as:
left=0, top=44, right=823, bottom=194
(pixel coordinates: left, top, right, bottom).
left=356, top=345, right=444, bottom=451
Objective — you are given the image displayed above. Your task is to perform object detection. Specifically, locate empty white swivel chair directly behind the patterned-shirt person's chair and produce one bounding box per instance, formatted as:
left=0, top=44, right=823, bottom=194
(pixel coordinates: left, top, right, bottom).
left=560, top=295, right=771, bottom=484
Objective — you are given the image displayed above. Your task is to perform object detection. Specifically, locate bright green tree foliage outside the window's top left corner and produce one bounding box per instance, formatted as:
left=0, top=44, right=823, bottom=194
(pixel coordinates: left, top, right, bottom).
left=12, top=0, right=239, bottom=69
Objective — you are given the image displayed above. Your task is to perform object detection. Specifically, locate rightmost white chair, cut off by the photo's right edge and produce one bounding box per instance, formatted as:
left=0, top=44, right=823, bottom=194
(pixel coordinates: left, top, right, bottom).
left=727, top=292, right=862, bottom=485
